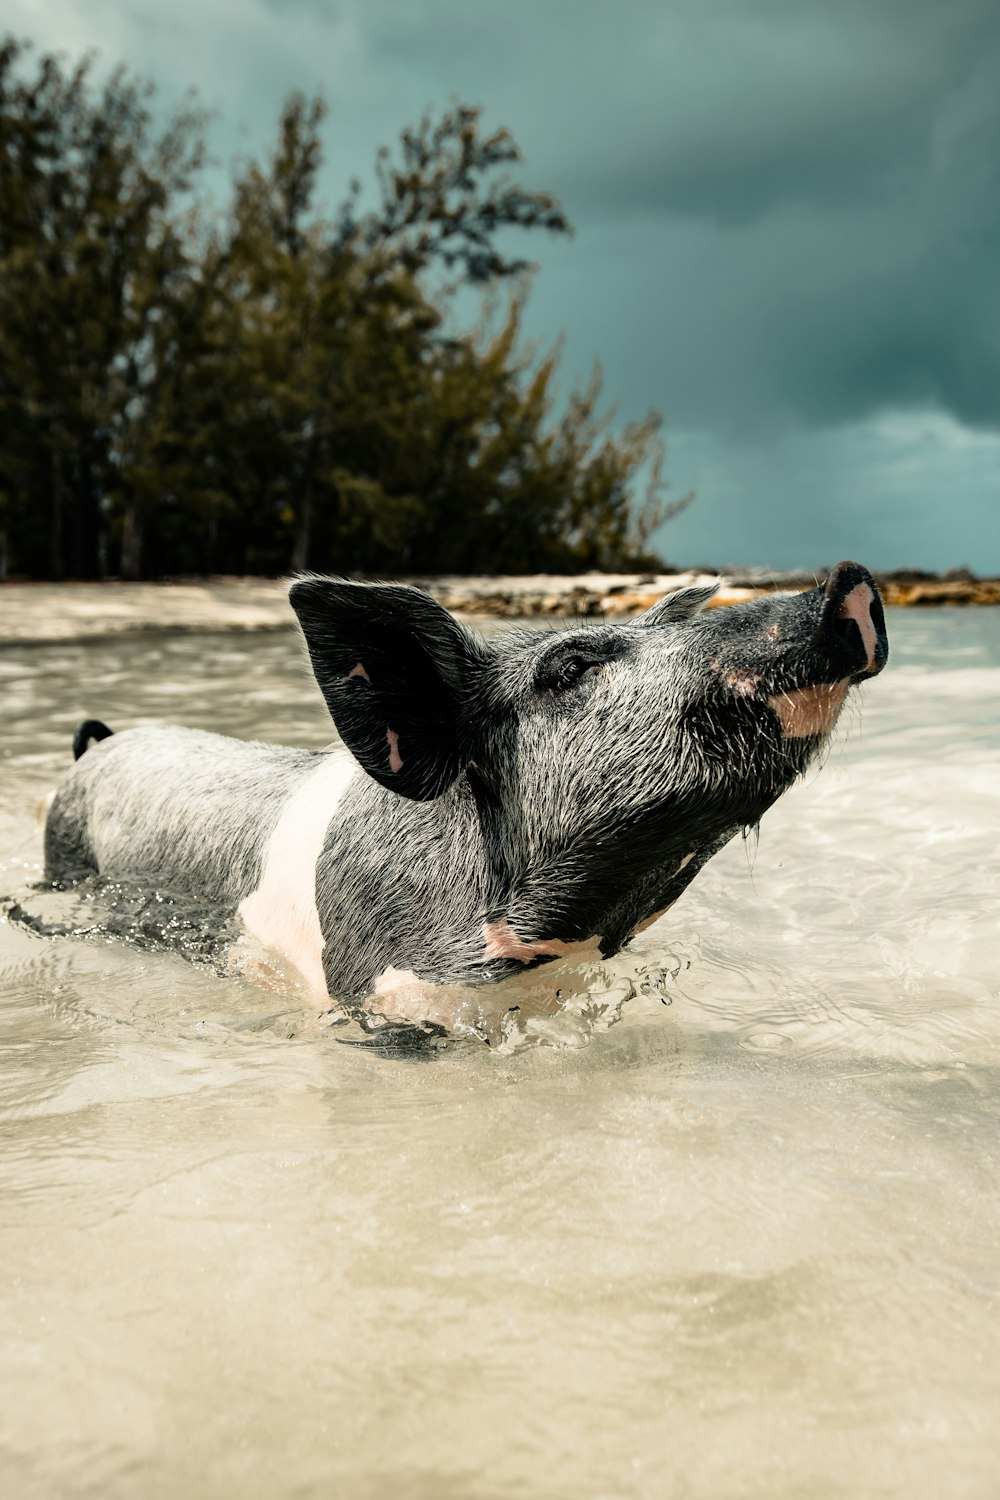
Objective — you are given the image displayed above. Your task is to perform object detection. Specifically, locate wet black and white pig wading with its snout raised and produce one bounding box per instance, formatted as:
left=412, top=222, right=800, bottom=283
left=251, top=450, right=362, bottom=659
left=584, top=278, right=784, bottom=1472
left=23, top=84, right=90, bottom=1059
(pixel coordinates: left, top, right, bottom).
left=45, top=563, right=888, bottom=1010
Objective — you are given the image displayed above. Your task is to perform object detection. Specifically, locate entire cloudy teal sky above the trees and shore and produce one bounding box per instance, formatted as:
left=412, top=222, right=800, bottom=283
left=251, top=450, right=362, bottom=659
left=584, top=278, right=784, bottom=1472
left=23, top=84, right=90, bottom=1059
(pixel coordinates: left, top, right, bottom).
left=7, top=0, right=1000, bottom=575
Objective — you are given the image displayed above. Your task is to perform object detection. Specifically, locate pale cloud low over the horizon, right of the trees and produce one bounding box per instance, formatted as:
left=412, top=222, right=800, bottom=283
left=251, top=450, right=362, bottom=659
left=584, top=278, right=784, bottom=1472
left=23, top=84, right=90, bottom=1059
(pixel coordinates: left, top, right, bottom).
left=660, top=411, right=1000, bottom=573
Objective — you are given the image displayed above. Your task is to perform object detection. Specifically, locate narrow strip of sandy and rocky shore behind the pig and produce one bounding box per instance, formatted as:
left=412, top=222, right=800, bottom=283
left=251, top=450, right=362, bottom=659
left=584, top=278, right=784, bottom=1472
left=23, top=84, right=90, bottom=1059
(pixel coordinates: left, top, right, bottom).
left=0, top=570, right=1000, bottom=647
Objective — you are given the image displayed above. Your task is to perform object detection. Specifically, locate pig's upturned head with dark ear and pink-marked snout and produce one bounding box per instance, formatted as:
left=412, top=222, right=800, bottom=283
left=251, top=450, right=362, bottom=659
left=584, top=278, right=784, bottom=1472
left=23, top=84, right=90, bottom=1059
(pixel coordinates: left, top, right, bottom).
left=291, top=563, right=888, bottom=978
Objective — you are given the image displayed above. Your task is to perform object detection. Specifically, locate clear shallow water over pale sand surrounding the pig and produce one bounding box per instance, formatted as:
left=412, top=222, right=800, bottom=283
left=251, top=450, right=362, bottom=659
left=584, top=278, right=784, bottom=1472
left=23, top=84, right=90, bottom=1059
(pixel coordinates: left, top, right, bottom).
left=0, top=609, right=1000, bottom=1500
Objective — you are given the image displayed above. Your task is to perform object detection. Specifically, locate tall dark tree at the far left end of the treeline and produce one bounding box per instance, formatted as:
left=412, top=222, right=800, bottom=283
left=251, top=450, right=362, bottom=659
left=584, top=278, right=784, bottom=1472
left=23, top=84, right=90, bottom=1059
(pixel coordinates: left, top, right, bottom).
left=0, top=39, right=201, bottom=578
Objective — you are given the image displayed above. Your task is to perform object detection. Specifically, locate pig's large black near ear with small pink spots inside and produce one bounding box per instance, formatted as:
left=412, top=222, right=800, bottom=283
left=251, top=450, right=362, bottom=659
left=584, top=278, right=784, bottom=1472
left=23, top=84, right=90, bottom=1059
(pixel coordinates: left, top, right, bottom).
left=288, top=578, right=487, bottom=801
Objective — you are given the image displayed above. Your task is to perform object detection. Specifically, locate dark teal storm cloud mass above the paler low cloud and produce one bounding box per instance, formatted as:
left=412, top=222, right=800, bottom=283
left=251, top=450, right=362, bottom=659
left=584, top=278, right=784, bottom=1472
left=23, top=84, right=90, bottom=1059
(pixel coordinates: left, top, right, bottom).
left=326, top=0, right=1000, bottom=431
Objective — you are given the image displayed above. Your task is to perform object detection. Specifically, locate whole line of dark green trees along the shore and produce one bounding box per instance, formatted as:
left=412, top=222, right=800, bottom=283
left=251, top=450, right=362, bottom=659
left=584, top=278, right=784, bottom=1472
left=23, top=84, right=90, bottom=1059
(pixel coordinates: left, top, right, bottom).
left=0, top=38, right=689, bottom=578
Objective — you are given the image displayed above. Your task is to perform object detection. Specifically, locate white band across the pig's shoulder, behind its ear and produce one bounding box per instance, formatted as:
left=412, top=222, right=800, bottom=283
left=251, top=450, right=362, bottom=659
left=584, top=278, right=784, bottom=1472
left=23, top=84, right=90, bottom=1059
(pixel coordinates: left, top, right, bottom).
left=237, top=753, right=357, bottom=995
